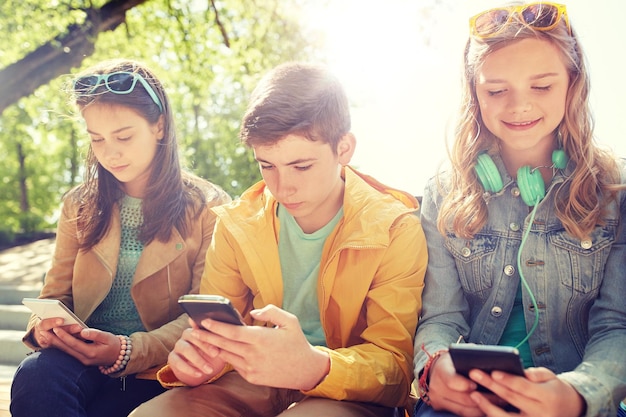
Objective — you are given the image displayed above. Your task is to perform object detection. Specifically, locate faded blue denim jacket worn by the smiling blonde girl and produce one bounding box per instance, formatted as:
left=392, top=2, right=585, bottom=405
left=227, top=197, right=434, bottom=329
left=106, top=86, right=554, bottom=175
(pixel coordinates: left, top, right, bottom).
left=415, top=156, right=626, bottom=416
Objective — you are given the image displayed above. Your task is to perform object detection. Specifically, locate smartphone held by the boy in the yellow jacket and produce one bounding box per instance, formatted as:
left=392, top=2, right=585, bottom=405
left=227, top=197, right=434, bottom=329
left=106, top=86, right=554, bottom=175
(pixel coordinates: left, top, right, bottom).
left=178, top=294, right=244, bottom=327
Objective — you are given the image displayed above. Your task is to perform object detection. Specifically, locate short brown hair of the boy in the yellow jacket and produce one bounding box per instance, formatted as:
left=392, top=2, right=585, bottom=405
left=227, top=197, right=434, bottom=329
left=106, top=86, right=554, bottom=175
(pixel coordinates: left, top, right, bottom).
left=239, top=63, right=350, bottom=151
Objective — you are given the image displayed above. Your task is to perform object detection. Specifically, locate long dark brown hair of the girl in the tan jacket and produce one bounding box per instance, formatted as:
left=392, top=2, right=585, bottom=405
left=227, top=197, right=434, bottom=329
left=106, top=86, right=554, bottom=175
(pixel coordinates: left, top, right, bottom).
left=66, top=60, right=219, bottom=250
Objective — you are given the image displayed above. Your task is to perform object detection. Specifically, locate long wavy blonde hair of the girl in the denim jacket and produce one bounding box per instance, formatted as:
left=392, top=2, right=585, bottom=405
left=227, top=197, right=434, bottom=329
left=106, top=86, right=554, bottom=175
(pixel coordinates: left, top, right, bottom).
left=438, top=14, right=621, bottom=239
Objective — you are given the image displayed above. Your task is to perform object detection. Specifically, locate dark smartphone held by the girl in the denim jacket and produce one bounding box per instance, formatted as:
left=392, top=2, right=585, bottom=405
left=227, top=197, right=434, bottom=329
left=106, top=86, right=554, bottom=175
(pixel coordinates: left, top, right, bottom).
left=449, top=343, right=524, bottom=392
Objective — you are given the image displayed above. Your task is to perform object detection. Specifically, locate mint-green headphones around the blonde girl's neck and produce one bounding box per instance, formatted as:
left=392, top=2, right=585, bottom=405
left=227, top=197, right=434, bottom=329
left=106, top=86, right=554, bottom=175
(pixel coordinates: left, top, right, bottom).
left=474, top=149, right=567, bottom=207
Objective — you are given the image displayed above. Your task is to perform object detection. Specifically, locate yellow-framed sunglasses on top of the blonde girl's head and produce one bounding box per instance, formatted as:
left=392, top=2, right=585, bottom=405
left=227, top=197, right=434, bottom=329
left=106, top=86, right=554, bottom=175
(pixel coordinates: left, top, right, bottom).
left=470, top=2, right=572, bottom=38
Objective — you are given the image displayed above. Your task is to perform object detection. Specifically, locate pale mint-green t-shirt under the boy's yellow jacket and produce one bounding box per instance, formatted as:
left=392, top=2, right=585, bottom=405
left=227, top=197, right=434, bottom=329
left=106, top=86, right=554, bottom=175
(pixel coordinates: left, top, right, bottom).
left=278, top=205, right=343, bottom=346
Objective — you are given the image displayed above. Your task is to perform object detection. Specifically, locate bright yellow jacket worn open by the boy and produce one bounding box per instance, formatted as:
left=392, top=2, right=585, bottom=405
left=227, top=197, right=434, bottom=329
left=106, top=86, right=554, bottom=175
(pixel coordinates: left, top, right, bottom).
left=159, top=168, right=427, bottom=407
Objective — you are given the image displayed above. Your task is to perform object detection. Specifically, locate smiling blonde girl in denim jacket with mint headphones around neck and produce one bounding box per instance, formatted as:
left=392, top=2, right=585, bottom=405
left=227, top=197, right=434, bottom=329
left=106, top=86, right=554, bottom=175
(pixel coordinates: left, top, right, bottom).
left=415, top=2, right=626, bottom=417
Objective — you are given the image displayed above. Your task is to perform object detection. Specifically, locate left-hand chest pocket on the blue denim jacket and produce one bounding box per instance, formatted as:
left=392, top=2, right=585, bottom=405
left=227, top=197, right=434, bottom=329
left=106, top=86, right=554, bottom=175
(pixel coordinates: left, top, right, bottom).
left=446, top=235, right=499, bottom=293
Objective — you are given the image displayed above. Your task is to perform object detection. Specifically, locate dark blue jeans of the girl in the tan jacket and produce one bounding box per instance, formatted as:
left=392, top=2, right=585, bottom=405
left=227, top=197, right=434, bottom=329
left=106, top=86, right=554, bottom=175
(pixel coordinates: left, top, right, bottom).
left=10, top=349, right=165, bottom=417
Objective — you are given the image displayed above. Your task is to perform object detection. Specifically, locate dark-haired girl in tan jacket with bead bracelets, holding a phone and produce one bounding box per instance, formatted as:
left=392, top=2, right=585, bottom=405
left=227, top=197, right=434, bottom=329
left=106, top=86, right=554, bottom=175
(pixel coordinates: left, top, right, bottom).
left=10, top=60, right=230, bottom=417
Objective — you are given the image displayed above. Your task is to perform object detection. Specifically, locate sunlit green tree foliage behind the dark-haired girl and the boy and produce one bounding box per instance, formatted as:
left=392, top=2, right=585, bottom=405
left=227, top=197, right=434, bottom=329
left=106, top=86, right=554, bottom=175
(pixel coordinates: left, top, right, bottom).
left=0, top=0, right=317, bottom=239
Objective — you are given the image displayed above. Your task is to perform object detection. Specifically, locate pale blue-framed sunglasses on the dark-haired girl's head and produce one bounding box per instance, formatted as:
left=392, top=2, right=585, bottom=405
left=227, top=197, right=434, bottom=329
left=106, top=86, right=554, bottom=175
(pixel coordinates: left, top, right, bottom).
left=74, top=71, right=163, bottom=112
